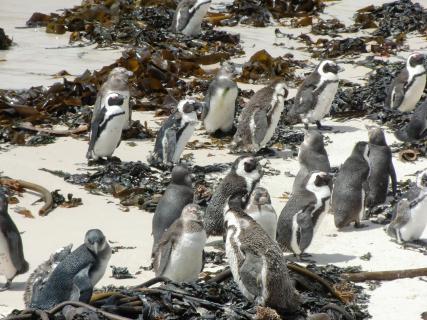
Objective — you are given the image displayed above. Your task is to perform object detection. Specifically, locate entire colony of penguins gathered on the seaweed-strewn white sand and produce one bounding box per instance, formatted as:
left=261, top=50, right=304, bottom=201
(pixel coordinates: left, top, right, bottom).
left=0, top=0, right=427, bottom=319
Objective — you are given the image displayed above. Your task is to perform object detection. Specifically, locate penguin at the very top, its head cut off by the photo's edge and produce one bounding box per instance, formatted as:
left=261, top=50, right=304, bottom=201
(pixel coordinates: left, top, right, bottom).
left=172, top=0, right=211, bottom=37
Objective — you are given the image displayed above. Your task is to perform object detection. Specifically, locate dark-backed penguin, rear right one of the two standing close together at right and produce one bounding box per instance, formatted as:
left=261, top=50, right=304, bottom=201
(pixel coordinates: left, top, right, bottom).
left=366, top=127, right=397, bottom=208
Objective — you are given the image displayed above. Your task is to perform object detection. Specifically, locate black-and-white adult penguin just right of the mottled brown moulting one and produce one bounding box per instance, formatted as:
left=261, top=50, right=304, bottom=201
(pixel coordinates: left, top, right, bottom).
left=289, top=60, right=339, bottom=130
